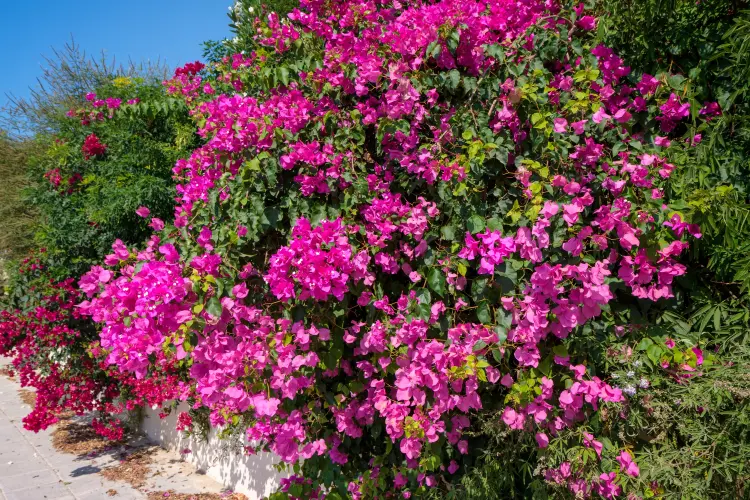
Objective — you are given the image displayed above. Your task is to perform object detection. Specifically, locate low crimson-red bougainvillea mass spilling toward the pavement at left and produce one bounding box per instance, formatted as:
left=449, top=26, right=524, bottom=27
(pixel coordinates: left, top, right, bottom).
left=0, top=249, right=177, bottom=440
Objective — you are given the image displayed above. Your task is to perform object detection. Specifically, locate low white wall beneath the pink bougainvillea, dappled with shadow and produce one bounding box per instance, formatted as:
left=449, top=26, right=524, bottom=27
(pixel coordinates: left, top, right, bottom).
left=141, top=403, right=288, bottom=500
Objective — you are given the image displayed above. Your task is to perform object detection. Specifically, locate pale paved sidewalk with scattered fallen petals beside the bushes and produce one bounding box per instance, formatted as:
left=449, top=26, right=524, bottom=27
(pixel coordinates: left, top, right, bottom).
left=0, top=359, right=238, bottom=500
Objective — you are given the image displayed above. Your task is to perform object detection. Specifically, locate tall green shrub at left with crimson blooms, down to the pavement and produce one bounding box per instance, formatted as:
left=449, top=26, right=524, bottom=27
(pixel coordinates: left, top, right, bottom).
left=0, top=77, right=200, bottom=438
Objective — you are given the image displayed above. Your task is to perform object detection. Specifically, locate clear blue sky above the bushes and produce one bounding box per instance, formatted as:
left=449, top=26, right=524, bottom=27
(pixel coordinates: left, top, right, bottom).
left=0, top=0, right=233, bottom=105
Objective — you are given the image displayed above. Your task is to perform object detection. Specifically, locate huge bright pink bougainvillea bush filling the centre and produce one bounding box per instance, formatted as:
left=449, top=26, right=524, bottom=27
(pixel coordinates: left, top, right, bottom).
left=1, top=0, right=747, bottom=499
